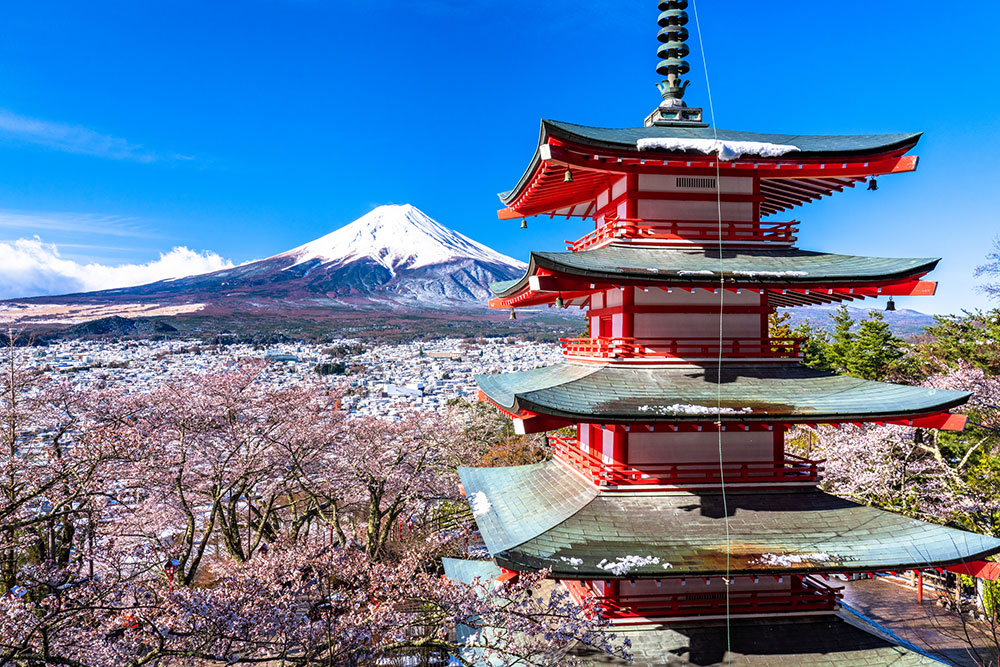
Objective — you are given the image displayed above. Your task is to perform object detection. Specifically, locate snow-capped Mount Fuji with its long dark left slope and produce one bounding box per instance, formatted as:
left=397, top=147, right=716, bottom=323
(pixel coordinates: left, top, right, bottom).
left=0, top=204, right=526, bottom=319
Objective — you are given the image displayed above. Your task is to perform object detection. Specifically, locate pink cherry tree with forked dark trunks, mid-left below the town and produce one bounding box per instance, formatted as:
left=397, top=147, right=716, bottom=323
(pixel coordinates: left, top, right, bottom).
left=102, top=364, right=342, bottom=584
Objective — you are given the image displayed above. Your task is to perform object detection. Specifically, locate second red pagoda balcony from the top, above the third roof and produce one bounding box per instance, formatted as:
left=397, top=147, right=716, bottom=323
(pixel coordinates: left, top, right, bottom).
left=560, top=336, right=805, bottom=364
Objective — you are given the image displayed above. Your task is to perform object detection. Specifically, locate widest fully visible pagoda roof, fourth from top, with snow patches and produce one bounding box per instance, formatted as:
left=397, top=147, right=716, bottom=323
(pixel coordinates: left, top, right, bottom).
left=459, top=461, right=1000, bottom=579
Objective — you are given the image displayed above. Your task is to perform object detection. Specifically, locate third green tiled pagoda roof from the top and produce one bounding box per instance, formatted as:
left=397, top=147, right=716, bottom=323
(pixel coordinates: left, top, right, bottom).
left=476, top=362, right=971, bottom=422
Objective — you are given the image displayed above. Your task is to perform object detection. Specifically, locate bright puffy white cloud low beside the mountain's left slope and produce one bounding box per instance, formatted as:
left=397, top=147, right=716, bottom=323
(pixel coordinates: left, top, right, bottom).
left=0, top=237, right=233, bottom=299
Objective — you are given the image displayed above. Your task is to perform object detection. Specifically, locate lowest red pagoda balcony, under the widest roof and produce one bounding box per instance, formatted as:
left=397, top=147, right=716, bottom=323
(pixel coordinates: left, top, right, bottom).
left=564, top=577, right=842, bottom=624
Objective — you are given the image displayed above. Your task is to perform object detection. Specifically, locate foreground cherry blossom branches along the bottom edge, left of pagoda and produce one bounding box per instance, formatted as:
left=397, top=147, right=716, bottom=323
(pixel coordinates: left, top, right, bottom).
left=0, top=543, right=628, bottom=667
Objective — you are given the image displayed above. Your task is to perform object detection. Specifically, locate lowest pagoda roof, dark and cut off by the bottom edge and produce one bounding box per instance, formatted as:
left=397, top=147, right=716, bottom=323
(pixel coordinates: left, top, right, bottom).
left=572, top=614, right=942, bottom=667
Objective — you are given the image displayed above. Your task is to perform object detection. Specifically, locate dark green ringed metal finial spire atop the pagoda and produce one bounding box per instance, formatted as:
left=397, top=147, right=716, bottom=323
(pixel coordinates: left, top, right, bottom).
left=646, top=0, right=705, bottom=127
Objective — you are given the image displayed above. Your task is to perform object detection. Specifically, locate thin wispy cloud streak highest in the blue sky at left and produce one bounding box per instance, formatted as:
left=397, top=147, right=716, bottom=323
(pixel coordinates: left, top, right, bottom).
left=0, top=109, right=184, bottom=163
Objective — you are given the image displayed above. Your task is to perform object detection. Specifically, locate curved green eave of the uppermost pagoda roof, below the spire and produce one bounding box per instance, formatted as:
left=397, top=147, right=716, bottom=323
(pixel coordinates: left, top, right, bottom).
left=498, top=119, right=922, bottom=209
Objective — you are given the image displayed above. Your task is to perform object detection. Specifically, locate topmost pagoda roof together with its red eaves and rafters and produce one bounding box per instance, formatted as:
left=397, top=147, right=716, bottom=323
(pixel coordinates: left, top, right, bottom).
left=499, top=120, right=921, bottom=216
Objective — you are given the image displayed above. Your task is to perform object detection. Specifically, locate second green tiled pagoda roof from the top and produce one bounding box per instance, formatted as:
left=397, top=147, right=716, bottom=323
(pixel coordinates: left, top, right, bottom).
left=490, top=244, right=940, bottom=296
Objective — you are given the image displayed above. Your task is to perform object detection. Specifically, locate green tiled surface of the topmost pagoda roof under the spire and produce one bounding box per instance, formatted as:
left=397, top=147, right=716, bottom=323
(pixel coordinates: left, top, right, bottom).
left=500, top=120, right=920, bottom=204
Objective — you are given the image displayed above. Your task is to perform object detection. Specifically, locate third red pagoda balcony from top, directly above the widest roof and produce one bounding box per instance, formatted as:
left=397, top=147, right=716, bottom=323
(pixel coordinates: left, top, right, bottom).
left=549, top=436, right=824, bottom=491
